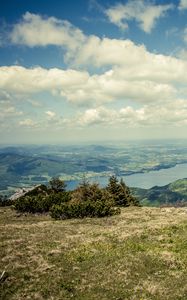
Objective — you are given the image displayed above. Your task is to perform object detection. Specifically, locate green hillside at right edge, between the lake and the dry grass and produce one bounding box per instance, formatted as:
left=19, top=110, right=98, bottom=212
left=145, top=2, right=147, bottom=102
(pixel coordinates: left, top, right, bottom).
left=132, top=178, right=187, bottom=206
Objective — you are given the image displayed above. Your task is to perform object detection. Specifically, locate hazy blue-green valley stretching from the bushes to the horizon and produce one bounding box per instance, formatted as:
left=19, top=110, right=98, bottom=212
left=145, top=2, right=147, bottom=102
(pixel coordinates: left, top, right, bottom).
left=0, top=140, right=187, bottom=194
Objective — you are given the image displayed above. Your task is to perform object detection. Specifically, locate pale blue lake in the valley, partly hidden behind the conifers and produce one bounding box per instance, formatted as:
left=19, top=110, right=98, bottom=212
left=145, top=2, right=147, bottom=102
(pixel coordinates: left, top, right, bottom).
left=67, top=164, right=187, bottom=190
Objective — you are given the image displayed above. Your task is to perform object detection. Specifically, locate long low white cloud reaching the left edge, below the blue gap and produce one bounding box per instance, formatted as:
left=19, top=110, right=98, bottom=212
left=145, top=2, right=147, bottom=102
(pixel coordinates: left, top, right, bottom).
left=0, top=66, right=89, bottom=93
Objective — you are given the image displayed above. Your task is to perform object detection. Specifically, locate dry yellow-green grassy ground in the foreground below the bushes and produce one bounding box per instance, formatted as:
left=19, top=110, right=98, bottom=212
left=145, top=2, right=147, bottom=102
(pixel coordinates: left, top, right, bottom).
left=0, top=207, right=187, bottom=300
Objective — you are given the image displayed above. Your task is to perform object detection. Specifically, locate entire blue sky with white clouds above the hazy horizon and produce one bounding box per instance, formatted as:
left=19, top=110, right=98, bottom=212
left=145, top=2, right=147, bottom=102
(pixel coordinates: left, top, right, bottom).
left=0, top=0, right=187, bottom=144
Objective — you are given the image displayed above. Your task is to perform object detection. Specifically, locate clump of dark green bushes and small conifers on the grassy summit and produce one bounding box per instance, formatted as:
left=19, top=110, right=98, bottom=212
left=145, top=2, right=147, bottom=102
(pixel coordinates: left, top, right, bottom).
left=14, top=176, right=137, bottom=219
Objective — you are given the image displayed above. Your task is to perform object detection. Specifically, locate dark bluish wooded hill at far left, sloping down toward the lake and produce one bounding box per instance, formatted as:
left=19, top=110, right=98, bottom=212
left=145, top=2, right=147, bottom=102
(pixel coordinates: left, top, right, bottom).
left=0, top=152, right=81, bottom=190
